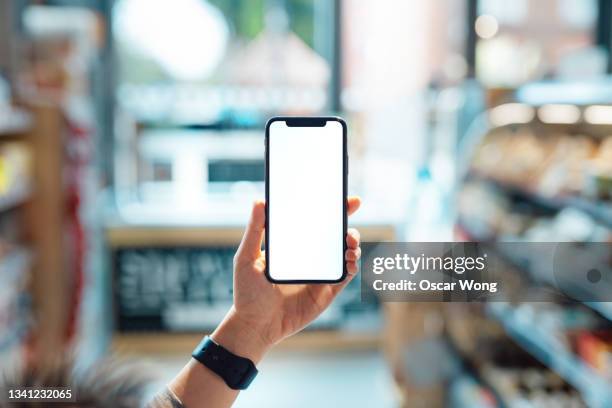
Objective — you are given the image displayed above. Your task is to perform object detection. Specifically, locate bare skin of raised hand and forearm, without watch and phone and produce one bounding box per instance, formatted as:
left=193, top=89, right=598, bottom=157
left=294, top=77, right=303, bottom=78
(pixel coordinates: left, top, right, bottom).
left=168, top=197, right=361, bottom=408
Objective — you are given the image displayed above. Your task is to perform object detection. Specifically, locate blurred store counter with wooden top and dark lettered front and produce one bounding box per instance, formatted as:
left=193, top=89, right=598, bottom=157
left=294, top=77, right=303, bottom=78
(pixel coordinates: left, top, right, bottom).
left=105, top=191, right=403, bottom=353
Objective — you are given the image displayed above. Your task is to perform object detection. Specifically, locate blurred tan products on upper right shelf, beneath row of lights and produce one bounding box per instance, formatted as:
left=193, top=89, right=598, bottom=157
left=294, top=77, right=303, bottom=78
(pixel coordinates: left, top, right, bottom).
left=472, top=126, right=612, bottom=200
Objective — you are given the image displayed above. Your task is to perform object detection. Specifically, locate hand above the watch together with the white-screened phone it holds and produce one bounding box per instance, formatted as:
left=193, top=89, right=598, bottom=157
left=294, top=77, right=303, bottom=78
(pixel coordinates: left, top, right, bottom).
left=206, top=118, right=361, bottom=362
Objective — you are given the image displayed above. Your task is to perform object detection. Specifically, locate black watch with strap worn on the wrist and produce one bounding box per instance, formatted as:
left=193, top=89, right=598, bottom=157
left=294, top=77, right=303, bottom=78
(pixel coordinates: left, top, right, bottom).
left=191, top=336, right=257, bottom=390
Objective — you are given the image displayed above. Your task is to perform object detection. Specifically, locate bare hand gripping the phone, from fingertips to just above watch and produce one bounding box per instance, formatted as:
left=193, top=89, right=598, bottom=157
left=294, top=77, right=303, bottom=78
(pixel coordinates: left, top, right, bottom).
left=212, top=197, right=361, bottom=361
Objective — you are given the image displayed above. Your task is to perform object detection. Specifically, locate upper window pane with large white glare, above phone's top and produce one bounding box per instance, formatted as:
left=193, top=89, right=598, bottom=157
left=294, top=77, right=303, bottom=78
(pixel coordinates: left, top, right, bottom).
left=113, top=0, right=332, bottom=124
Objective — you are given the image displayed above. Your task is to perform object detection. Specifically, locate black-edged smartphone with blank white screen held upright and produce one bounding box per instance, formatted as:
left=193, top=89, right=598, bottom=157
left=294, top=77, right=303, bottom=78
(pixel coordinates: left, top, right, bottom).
left=265, top=117, right=348, bottom=283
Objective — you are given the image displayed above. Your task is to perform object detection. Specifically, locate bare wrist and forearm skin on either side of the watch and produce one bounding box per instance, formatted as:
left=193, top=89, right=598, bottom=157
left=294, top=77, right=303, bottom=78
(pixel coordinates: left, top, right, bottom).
left=169, top=308, right=269, bottom=408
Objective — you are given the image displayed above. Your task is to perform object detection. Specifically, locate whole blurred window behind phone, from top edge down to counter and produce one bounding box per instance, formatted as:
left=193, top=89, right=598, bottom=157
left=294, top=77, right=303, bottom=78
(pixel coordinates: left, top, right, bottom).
left=112, top=0, right=334, bottom=201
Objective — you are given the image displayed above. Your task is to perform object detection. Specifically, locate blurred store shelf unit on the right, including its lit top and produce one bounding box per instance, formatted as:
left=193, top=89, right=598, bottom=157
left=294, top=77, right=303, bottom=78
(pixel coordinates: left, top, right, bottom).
left=450, top=80, right=612, bottom=407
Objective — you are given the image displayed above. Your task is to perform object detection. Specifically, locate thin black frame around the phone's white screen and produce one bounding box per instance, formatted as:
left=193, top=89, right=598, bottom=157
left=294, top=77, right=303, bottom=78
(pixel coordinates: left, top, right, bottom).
left=265, top=116, right=348, bottom=284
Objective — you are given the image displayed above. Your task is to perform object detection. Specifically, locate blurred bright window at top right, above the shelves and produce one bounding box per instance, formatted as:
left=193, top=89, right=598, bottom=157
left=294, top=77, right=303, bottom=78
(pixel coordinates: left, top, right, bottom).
left=475, top=0, right=607, bottom=87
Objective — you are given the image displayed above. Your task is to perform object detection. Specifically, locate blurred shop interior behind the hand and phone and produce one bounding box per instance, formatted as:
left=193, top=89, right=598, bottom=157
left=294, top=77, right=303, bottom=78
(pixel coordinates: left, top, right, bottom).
left=0, top=0, right=612, bottom=407
